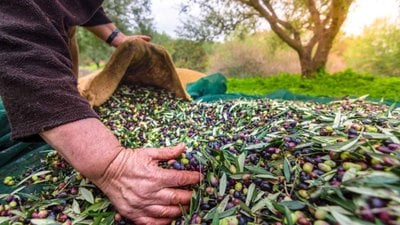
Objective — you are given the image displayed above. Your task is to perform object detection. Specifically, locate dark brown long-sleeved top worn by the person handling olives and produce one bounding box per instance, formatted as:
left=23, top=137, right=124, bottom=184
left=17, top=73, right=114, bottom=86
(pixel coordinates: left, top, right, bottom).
left=0, top=0, right=111, bottom=140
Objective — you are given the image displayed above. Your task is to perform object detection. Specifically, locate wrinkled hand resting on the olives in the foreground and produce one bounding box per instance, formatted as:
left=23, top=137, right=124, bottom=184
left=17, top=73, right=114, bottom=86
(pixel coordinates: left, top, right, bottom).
left=92, top=144, right=201, bottom=224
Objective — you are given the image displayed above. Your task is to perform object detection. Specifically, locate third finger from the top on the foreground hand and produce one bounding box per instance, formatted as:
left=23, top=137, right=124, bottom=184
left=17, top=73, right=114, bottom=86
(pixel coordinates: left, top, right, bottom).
left=155, top=188, right=192, bottom=205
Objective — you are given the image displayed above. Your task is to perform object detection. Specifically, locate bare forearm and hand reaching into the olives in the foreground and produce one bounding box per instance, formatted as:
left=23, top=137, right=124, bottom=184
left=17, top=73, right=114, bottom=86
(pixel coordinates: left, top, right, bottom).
left=40, top=119, right=200, bottom=224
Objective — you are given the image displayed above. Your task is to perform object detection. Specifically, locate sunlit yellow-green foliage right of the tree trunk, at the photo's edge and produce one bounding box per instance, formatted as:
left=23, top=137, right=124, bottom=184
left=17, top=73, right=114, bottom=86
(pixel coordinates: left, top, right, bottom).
left=344, top=19, right=400, bottom=75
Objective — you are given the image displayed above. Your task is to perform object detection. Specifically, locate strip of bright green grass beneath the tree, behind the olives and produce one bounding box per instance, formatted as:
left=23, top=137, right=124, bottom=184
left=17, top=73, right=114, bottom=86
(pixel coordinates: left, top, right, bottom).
left=228, top=70, right=400, bottom=101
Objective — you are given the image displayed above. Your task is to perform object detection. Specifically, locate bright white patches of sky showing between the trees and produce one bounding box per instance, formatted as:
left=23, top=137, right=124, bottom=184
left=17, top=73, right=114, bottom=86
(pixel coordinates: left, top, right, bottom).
left=152, top=0, right=400, bottom=37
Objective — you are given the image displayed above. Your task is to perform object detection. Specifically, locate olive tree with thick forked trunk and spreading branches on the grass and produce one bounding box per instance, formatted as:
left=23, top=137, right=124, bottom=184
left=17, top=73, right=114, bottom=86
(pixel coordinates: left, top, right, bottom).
left=180, top=0, right=354, bottom=77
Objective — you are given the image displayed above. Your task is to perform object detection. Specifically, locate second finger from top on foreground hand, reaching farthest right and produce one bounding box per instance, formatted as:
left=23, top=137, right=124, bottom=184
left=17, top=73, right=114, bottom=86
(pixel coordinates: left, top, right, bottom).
left=158, top=169, right=203, bottom=187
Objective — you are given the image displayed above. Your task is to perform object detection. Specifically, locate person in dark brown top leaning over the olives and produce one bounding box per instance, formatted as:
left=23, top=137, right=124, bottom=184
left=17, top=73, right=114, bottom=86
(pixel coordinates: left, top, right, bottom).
left=0, top=0, right=201, bottom=224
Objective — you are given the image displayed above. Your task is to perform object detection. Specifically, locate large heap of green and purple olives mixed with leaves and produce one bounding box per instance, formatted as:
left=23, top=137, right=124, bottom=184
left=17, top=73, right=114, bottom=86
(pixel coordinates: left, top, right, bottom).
left=0, top=86, right=400, bottom=225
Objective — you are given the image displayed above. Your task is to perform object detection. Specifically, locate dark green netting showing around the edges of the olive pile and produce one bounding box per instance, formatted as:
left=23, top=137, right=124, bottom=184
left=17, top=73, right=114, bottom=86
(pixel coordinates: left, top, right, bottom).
left=0, top=73, right=400, bottom=193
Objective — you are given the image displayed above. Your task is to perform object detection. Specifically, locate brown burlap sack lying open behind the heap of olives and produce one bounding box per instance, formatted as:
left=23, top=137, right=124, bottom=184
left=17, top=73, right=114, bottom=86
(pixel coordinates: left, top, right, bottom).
left=78, top=39, right=204, bottom=107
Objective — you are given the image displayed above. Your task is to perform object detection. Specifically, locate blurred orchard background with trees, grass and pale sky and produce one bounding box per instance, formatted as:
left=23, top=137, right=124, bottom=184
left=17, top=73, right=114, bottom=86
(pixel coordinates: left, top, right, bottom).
left=78, top=0, right=400, bottom=101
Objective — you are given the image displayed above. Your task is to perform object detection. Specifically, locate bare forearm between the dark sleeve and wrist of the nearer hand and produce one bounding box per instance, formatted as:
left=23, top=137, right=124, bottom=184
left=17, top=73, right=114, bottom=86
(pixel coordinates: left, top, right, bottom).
left=40, top=118, right=124, bottom=179
